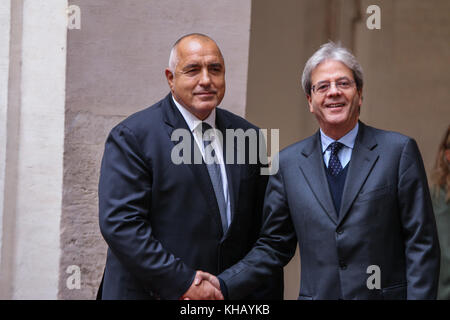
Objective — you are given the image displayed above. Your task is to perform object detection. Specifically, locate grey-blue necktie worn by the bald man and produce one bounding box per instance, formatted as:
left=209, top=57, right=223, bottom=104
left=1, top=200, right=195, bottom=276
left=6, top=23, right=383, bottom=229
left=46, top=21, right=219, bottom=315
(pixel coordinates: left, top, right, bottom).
left=202, top=122, right=228, bottom=233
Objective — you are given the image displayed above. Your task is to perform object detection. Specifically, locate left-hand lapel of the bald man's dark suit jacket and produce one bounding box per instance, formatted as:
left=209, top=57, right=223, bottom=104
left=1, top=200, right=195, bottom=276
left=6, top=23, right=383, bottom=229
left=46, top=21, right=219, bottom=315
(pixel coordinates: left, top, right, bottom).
left=163, top=94, right=223, bottom=233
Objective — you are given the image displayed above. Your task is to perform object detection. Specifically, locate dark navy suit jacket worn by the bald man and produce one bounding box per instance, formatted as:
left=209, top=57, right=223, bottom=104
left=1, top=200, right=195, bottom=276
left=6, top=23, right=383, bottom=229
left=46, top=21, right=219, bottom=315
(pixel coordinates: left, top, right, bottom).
left=99, top=94, right=283, bottom=299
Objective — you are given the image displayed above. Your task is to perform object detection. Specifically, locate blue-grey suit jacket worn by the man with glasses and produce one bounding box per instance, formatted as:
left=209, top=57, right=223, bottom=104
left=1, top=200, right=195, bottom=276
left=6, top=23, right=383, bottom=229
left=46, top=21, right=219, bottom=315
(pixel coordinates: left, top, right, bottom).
left=219, top=122, right=440, bottom=299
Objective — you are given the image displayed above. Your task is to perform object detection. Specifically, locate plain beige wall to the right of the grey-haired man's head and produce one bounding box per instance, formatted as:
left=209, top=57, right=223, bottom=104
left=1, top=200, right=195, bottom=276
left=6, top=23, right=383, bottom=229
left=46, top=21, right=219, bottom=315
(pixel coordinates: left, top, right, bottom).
left=355, top=0, right=450, bottom=173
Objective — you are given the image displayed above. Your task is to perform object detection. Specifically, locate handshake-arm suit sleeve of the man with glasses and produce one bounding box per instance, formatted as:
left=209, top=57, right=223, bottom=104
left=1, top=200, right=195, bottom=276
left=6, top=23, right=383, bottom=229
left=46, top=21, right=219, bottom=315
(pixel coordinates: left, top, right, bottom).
left=218, top=159, right=297, bottom=300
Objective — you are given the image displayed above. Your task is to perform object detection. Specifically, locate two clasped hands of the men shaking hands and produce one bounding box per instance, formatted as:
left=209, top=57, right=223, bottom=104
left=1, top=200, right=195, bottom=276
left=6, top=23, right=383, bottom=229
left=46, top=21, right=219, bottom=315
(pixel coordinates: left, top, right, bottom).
left=180, top=270, right=224, bottom=300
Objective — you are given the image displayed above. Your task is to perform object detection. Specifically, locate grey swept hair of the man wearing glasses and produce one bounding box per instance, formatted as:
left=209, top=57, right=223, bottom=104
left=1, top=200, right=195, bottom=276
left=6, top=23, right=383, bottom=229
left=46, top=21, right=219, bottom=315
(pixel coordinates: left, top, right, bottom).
left=302, top=41, right=364, bottom=95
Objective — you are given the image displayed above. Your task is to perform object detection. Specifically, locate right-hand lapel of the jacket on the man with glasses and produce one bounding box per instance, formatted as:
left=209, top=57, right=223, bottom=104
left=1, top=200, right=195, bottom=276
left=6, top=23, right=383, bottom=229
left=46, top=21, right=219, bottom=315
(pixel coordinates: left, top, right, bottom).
left=339, top=122, right=379, bottom=224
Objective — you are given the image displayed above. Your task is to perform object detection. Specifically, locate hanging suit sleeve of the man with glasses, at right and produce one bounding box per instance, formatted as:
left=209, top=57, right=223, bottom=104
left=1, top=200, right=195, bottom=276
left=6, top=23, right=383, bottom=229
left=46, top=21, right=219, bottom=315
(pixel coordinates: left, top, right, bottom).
left=398, top=139, right=440, bottom=299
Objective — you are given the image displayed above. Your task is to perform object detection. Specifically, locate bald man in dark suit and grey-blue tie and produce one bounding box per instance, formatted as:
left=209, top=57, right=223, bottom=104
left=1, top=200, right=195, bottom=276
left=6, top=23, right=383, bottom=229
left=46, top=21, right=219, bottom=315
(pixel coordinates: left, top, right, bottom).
left=98, top=34, right=283, bottom=300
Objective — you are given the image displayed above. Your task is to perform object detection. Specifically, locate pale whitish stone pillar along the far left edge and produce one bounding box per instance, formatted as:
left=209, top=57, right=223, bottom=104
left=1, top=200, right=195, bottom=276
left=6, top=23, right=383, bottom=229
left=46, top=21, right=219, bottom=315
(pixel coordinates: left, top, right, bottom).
left=0, top=0, right=67, bottom=299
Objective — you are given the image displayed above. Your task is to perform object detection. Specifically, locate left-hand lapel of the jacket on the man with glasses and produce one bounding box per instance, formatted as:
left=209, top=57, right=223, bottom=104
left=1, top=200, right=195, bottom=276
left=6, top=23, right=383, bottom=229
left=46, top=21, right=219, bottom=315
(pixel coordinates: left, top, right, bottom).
left=299, top=131, right=337, bottom=224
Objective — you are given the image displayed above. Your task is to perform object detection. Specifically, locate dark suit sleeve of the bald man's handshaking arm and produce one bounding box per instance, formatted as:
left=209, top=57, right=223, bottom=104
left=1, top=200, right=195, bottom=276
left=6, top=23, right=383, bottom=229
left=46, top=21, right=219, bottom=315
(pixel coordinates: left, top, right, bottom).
left=98, top=125, right=195, bottom=299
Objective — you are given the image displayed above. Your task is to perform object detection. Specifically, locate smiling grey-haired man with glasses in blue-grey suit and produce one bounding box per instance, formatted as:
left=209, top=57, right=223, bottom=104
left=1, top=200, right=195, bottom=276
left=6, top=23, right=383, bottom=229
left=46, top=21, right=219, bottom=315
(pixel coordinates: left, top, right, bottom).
left=210, top=42, right=440, bottom=300
